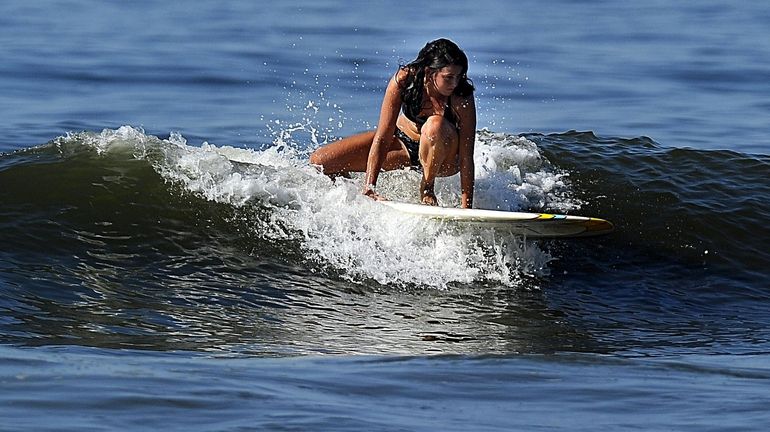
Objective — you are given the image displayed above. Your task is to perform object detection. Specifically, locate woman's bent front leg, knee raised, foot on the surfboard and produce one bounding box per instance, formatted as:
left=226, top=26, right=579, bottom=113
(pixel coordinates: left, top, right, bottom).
left=420, top=116, right=460, bottom=205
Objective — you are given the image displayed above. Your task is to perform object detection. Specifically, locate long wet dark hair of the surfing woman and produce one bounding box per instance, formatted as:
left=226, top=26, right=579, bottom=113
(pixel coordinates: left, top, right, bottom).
left=399, top=39, right=474, bottom=118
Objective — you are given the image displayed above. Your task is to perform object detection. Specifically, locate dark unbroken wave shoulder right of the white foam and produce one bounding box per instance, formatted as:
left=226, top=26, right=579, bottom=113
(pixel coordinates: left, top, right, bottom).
left=528, top=131, right=770, bottom=275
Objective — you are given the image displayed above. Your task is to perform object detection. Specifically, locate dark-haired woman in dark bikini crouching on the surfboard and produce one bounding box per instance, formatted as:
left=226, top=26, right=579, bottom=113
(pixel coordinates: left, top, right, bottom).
left=310, top=39, right=476, bottom=208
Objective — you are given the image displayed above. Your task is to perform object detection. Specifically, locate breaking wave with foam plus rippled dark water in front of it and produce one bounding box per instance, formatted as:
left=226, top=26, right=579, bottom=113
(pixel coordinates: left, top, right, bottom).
left=0, top=126, right=770, bottom=355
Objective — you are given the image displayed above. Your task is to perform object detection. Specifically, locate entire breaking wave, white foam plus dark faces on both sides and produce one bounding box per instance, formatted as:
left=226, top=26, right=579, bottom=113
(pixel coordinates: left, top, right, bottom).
left=0, top=126, right=770, bottom=288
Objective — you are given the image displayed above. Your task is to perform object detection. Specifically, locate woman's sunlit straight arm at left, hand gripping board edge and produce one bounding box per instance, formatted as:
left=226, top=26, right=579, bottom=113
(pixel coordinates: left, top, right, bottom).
left=364, top=69, right=406, bottom=199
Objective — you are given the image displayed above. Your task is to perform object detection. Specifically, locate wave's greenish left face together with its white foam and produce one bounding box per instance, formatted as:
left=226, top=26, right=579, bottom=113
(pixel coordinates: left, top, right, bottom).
left=0, top=126, right=582, bottom=288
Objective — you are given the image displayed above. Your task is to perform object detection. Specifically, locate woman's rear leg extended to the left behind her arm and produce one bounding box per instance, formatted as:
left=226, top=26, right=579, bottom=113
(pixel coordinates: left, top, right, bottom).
left=310, top=131, right=409, bottom=176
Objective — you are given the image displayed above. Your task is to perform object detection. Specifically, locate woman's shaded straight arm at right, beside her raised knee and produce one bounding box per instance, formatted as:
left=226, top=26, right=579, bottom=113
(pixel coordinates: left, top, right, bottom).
left=455, top=93, right=476, bottom=208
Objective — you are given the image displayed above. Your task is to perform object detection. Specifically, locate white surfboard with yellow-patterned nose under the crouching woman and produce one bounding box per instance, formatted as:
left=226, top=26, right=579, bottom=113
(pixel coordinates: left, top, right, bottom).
left=380, top=201, right=614, bottom=238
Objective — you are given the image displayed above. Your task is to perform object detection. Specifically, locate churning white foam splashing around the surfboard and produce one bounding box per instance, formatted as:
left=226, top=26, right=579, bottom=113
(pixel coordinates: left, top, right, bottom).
left=66, top=127, right=577, bottom=288
